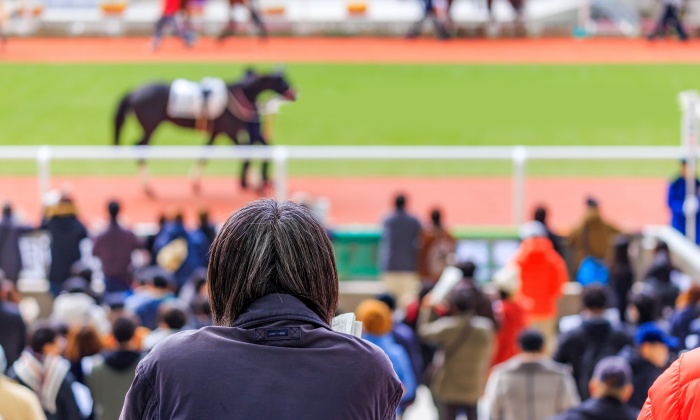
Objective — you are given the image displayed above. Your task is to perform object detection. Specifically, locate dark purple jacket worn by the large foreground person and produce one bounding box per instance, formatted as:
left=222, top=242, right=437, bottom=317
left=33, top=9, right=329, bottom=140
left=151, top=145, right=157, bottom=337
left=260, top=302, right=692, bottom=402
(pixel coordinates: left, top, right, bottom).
left=121, top=294, right=403, bottom=420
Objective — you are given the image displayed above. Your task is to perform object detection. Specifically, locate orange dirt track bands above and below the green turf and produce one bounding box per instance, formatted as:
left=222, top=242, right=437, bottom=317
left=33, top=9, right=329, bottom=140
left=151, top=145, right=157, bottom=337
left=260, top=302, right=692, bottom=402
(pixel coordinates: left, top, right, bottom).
left=0, top=38, right=688, bottom=230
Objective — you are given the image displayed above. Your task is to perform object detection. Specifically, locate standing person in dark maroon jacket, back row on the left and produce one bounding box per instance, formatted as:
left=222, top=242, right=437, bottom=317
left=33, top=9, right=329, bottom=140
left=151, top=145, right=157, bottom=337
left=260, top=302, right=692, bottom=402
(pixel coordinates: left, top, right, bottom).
left=92, top=201, right=143, bottom=293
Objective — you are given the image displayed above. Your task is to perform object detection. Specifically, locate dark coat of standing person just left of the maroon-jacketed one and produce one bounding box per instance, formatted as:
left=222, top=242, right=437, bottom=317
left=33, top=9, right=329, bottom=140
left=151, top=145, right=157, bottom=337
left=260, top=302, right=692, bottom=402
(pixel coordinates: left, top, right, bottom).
left=41, top=214, right=87, bottom=291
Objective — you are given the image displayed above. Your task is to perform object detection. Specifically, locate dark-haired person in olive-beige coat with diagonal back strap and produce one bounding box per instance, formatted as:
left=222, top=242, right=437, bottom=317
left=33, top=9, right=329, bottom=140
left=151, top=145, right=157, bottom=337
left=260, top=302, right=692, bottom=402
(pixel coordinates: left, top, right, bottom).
left=418, top=293, right=495, bottom=420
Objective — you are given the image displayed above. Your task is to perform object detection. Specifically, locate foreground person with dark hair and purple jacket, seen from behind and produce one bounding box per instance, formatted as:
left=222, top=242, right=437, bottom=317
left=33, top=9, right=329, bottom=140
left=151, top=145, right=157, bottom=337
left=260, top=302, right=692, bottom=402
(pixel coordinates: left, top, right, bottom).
left=122, top=199, right=403, bottom=419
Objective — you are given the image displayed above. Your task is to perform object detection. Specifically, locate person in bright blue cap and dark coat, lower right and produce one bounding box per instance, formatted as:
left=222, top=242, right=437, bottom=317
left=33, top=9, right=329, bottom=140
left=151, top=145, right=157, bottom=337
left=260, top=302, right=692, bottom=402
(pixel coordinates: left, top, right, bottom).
left=620, top=324, right=678, bottom=410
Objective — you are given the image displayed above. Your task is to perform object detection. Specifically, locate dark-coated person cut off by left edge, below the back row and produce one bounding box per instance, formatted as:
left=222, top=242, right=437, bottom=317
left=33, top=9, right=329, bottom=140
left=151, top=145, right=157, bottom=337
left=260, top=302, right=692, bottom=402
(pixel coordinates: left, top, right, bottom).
left=0, top=280, right=27, bottom=374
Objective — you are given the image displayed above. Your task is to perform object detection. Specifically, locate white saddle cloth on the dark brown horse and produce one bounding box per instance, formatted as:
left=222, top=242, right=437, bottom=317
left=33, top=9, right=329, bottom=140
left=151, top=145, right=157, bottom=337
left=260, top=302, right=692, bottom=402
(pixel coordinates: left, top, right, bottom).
left=168, top=77, right=228, bottom=120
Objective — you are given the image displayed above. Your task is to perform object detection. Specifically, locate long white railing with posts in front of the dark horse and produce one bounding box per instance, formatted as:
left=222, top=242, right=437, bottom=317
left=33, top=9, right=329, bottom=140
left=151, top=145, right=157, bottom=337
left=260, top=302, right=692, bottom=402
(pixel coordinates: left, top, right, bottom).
left=0, top=146, right=684, bottom=225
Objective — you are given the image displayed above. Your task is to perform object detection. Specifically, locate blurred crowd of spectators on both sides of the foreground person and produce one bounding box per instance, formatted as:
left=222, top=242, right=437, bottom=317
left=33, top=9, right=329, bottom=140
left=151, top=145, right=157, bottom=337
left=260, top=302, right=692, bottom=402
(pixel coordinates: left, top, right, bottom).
left=0, top=191, right=700, bottom=420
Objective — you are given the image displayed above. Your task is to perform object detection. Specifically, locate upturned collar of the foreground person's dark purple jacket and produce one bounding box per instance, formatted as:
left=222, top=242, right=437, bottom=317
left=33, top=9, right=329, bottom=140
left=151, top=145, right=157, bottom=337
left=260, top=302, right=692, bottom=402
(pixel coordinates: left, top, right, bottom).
left=233, top=293, right=331, bottom=330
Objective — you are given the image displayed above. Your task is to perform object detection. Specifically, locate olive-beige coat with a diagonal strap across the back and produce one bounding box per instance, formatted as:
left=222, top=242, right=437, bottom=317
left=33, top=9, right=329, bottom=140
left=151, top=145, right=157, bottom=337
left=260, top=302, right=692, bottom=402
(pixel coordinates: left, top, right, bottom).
left=418, top=311, right=495, bottom=405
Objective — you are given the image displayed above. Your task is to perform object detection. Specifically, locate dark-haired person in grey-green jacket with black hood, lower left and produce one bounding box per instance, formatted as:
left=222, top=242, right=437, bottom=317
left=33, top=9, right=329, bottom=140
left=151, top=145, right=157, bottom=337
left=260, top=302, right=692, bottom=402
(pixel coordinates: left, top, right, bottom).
left=86, top=317, right=142, bottom=420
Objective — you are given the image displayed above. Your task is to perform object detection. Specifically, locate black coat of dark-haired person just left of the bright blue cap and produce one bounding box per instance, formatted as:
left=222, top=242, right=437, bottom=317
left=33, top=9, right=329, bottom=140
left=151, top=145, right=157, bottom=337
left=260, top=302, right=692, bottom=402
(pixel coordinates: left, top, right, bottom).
left=554, top=318, right=632, bottom=401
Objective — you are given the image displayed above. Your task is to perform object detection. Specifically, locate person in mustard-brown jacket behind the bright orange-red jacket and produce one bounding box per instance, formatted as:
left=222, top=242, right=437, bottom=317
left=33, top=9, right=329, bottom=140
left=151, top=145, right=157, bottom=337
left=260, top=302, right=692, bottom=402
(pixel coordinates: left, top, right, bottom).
left=567, top=198, right=621, bottom=280
